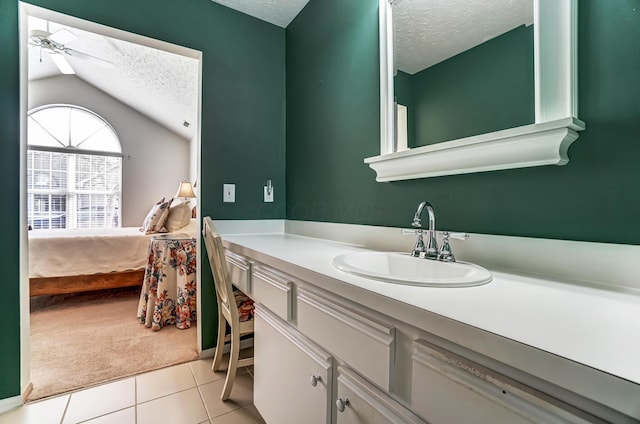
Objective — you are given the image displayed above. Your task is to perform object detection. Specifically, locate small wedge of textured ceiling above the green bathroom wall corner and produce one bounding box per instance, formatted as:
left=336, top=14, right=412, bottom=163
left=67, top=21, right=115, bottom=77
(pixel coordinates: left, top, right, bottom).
left=212, top=0, right=310, bottom=28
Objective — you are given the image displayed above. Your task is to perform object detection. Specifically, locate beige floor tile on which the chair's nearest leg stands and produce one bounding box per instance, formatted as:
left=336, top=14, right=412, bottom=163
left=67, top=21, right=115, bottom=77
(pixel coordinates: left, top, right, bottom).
left=199, top=372, right=253, bottom=418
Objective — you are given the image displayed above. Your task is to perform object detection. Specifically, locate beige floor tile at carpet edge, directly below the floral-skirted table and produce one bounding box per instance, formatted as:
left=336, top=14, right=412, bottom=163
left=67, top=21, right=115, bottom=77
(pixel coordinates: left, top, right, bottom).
left=136, top=364, right=196, bottom=403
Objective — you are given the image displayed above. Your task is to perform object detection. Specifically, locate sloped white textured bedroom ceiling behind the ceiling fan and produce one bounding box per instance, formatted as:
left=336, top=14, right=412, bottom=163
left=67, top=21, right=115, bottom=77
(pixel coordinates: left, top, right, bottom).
left=29, top=17, right=198, bottom=140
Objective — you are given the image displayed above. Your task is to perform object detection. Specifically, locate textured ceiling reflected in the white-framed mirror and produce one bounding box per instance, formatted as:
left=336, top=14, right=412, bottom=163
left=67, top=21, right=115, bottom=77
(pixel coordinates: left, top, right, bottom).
left=393, top=0, right=533, bottom=74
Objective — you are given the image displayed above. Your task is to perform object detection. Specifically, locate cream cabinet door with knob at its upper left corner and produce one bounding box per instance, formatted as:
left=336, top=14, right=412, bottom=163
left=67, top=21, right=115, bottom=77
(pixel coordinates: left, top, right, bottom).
left=336, top=366, right=425, bottom=424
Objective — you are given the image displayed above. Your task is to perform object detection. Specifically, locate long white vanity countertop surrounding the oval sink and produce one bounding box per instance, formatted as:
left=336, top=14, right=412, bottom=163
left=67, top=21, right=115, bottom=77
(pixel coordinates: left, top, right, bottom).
left=223, top=234, right=640, bottom=384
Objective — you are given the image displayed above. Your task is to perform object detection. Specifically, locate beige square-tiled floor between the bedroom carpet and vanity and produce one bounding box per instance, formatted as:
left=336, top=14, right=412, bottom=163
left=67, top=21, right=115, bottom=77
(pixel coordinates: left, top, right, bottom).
left=0, top=359, right=264, bottom=424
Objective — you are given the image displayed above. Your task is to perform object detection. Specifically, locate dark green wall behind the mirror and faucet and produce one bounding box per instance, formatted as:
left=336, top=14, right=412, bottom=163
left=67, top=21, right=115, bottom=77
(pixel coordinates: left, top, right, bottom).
left=286, top=0, right=640, bottom=248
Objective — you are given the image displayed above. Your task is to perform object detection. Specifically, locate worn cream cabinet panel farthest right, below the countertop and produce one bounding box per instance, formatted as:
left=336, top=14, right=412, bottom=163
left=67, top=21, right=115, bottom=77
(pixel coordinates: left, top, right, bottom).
left=411, top=340, right=600, bottom=424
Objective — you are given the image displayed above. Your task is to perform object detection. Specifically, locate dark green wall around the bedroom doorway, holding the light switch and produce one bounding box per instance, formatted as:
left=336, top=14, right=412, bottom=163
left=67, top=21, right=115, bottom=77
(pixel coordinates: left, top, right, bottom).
left=0, top=0, right=285, bottom=399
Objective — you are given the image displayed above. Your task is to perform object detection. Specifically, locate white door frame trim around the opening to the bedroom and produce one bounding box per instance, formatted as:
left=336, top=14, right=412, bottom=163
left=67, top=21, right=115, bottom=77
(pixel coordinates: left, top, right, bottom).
left=20, top=3, right=202, bottom=400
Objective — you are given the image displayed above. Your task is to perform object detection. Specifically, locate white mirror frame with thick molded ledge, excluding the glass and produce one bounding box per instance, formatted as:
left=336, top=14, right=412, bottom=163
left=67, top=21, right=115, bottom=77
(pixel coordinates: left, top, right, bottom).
left=364, top=0, right=585, bottom=182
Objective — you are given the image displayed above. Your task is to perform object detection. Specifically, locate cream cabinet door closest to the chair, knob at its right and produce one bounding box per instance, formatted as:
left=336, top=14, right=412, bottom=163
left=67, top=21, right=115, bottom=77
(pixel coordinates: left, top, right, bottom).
left=253, top=304, right=332, bottom=424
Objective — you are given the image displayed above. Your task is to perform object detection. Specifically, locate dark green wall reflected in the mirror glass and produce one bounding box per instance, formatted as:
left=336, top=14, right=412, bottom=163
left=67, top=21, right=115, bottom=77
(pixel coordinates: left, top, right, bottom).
left=394, top=25, right=534, bottom=147
